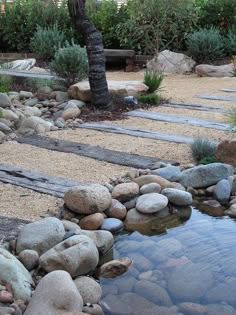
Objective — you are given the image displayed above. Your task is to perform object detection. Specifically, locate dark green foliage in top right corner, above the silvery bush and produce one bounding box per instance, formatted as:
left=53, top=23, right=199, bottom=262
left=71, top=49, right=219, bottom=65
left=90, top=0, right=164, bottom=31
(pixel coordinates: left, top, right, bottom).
left=195, top=0, right=236, bottom=34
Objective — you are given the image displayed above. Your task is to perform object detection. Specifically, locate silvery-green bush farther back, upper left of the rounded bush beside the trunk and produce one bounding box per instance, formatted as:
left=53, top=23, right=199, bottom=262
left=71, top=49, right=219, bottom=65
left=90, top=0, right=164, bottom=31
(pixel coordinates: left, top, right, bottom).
left=30, top=24, right=66, bottom=60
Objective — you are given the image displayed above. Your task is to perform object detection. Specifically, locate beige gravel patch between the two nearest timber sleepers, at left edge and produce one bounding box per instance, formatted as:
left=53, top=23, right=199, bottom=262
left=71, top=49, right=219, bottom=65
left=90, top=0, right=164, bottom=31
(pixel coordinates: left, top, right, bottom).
left=0, top=183, right=63, bottom=221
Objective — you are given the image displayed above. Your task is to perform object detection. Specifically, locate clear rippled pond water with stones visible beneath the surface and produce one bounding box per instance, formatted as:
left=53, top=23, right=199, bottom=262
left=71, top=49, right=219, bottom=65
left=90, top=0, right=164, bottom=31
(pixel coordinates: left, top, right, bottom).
left=100, top=208, right=236, bottom=315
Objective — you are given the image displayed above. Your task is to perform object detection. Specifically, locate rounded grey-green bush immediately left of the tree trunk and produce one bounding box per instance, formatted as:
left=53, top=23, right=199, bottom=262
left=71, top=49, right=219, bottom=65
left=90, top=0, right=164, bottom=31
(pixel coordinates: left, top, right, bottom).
left=50, top=44, right=88, bottom=86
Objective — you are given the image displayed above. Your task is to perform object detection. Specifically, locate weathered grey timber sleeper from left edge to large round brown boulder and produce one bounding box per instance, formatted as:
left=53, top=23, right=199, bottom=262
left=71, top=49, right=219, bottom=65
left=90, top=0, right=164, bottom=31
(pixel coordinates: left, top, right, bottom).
left=0, top=163, right=82, bottom=198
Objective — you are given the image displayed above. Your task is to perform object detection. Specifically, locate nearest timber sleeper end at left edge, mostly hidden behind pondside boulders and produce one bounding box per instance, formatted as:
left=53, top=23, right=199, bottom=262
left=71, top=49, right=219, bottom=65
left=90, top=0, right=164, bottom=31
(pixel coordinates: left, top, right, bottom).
left=0, top=216, right=30, bottom=246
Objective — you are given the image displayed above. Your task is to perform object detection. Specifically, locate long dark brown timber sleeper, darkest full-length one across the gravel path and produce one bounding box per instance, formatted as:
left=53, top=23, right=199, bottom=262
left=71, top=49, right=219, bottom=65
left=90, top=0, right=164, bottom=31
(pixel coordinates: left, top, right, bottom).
left=17, top=135, right=177, bottom=169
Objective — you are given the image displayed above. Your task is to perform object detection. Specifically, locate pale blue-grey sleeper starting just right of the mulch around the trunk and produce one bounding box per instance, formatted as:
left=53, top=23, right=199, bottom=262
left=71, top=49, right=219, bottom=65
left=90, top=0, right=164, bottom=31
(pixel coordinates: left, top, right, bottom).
left=125, top=110, right=230, bottom=130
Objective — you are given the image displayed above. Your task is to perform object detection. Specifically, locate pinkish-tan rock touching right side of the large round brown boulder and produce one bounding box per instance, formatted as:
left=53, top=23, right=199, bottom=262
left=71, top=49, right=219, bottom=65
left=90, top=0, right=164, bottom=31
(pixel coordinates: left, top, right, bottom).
left=111, top=182, right=139, bottom=202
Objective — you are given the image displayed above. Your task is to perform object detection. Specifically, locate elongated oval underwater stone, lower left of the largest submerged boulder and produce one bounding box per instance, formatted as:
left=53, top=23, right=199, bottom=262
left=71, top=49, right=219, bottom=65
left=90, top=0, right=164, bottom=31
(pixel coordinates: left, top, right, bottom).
left=134, top=280, right=172, bottom=306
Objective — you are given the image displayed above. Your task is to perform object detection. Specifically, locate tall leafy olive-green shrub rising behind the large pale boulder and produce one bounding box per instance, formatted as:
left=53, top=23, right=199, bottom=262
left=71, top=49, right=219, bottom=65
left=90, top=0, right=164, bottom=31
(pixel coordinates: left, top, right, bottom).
left=117, top=0, right=198, bottom=55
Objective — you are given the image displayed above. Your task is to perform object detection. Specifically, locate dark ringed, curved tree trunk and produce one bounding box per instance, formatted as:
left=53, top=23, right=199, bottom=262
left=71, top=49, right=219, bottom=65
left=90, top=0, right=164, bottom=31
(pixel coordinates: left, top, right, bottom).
left=68, top=0, right=111, bottom=110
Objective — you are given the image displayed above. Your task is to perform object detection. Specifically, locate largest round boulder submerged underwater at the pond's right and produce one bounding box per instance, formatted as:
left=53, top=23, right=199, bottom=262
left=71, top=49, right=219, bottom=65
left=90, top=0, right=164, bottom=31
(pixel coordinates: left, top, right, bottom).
left=167, top=263, right=213, bottom=302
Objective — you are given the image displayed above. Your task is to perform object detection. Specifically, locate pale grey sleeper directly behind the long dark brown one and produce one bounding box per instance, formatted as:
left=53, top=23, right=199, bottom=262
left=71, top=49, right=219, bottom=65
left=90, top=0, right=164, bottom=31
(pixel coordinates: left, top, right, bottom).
left=79, top=122, right=194, bottom=144
